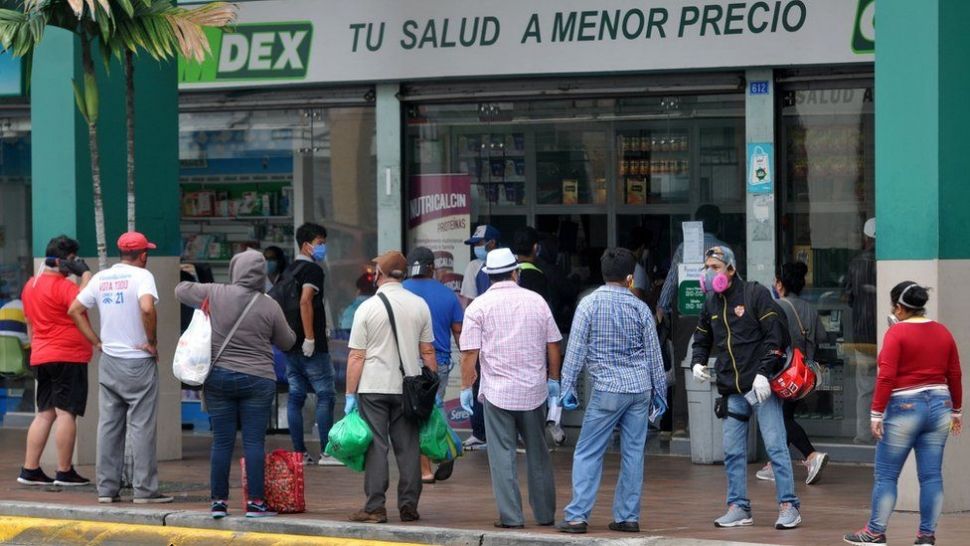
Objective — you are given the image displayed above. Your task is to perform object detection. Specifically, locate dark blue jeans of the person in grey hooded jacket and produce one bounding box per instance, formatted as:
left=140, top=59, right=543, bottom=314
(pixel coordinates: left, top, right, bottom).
left=204, top=368, right=276, bottom=500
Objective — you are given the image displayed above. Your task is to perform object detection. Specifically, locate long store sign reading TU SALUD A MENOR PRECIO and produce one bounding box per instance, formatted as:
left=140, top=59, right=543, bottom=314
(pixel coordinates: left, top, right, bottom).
left=180, top=0, right=875, bottom=88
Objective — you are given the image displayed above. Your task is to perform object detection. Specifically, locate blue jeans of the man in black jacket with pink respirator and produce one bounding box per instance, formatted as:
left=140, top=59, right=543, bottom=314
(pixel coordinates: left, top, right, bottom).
left=724, top=394, right=800, bottom=510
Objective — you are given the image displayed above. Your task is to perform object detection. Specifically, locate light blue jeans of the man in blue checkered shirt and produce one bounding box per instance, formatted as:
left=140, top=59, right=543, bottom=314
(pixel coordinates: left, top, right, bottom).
left=564, top=390, right=651, bottom=522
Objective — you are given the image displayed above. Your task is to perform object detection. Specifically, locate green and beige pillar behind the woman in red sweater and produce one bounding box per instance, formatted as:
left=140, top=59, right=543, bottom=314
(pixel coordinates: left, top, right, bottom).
left=876, top=0, right=970, bottom=512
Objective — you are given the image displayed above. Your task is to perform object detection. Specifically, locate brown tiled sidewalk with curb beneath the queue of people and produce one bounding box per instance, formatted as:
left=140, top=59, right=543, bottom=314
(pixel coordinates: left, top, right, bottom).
left=0, top=429, right=970, bottom=545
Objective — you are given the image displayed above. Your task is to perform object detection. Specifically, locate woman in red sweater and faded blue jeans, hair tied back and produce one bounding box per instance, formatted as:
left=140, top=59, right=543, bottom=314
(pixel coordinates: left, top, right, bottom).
left=844, top=281, right=963, bottom=544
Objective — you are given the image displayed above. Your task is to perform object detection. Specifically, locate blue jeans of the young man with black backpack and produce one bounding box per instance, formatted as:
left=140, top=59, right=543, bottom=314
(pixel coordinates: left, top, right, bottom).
left=286, top=351, right=334, bottom=453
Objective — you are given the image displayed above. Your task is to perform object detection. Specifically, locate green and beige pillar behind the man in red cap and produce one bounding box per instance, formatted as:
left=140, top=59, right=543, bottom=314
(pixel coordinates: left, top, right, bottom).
left=30, top=28, right=182, bottom=464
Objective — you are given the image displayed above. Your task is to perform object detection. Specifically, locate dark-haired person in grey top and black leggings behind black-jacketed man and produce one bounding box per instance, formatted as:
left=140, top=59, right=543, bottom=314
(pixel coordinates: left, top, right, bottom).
left=755, top=262, right=829, bottom=485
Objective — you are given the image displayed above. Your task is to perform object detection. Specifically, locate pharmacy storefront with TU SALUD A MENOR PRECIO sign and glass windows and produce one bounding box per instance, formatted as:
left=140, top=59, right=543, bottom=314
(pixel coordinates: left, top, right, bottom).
left=179, top=0, right=875, bottom=444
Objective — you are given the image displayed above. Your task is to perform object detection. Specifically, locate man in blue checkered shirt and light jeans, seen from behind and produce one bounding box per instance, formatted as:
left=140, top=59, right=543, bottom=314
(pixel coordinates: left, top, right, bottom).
left=559, top=248, right=667, bottom=533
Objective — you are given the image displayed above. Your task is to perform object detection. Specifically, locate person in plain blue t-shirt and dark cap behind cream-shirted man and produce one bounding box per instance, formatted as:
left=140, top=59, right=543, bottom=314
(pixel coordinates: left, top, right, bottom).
left=404, top=246, right=465, bottom=483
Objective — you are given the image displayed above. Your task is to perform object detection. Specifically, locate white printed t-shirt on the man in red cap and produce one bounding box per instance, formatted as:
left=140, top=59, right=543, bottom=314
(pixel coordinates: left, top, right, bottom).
left=77, top=264, right=158, bottom=358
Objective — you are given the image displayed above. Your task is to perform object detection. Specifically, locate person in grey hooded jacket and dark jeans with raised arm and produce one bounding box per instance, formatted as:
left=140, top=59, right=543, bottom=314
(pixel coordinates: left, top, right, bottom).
left=175, top=250, right=296, bottom=519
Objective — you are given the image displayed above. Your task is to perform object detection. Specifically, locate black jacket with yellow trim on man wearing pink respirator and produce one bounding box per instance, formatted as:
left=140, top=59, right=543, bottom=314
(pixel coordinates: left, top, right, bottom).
left=691, top=277, right=791, bottom=395
